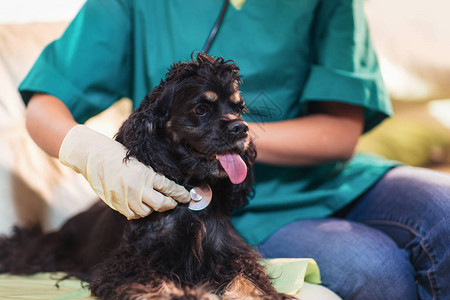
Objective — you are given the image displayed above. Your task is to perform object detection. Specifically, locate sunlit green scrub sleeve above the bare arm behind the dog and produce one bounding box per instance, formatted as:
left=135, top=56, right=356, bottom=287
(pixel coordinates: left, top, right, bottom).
left=300, top=0, right=392, bottom=131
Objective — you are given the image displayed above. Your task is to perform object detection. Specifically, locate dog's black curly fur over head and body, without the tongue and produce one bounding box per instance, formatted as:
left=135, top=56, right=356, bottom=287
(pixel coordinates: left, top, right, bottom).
left=0, top=53, right=291, bottom=300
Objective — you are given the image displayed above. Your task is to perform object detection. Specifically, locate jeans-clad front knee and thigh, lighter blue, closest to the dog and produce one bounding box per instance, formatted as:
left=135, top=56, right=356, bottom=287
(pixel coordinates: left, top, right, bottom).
left=260, top=219, right=417, bottom=300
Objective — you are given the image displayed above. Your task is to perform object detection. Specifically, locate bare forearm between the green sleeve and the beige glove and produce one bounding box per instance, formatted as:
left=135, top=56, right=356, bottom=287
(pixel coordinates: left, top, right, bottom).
left=26, top=93, right=77, bottom=157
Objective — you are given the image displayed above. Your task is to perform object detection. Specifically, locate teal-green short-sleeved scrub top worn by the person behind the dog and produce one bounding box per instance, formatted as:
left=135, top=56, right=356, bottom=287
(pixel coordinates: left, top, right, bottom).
left=19, top=0, right=396, bottom=245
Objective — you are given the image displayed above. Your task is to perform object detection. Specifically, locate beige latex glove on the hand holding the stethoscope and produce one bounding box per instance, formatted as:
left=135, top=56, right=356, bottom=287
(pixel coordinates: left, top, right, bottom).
left=59, top=125, right=191, bottom=219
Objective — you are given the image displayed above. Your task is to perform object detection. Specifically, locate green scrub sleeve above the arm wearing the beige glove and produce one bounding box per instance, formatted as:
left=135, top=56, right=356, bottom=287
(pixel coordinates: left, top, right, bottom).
left=19, top=0, right=132, bottom=123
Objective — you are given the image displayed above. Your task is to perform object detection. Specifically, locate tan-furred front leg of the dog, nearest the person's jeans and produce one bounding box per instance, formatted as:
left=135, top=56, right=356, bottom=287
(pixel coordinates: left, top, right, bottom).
left=221, top=275, right=297, bottom=300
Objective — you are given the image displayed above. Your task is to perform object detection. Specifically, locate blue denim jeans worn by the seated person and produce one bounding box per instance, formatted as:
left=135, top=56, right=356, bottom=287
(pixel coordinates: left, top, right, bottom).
left=259, top=166, right=450, bottom=300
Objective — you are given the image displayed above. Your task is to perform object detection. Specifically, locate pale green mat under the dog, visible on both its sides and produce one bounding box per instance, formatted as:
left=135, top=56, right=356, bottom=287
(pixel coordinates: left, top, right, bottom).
left=0, top=258, right=320, bottom=300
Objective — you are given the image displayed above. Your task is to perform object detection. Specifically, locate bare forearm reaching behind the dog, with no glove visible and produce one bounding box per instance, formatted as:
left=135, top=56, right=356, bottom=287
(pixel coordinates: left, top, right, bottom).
left=249, top=103, right=363, bottom=165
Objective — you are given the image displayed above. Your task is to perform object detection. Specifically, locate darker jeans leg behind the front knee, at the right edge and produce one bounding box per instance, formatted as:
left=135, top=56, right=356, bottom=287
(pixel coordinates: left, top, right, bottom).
left=347, top=167, right=450, bottom=299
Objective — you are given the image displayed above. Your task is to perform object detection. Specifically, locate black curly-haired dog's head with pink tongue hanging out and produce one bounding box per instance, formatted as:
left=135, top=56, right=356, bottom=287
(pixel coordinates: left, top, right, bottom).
left=117, top=53, right=256, bottom=209
